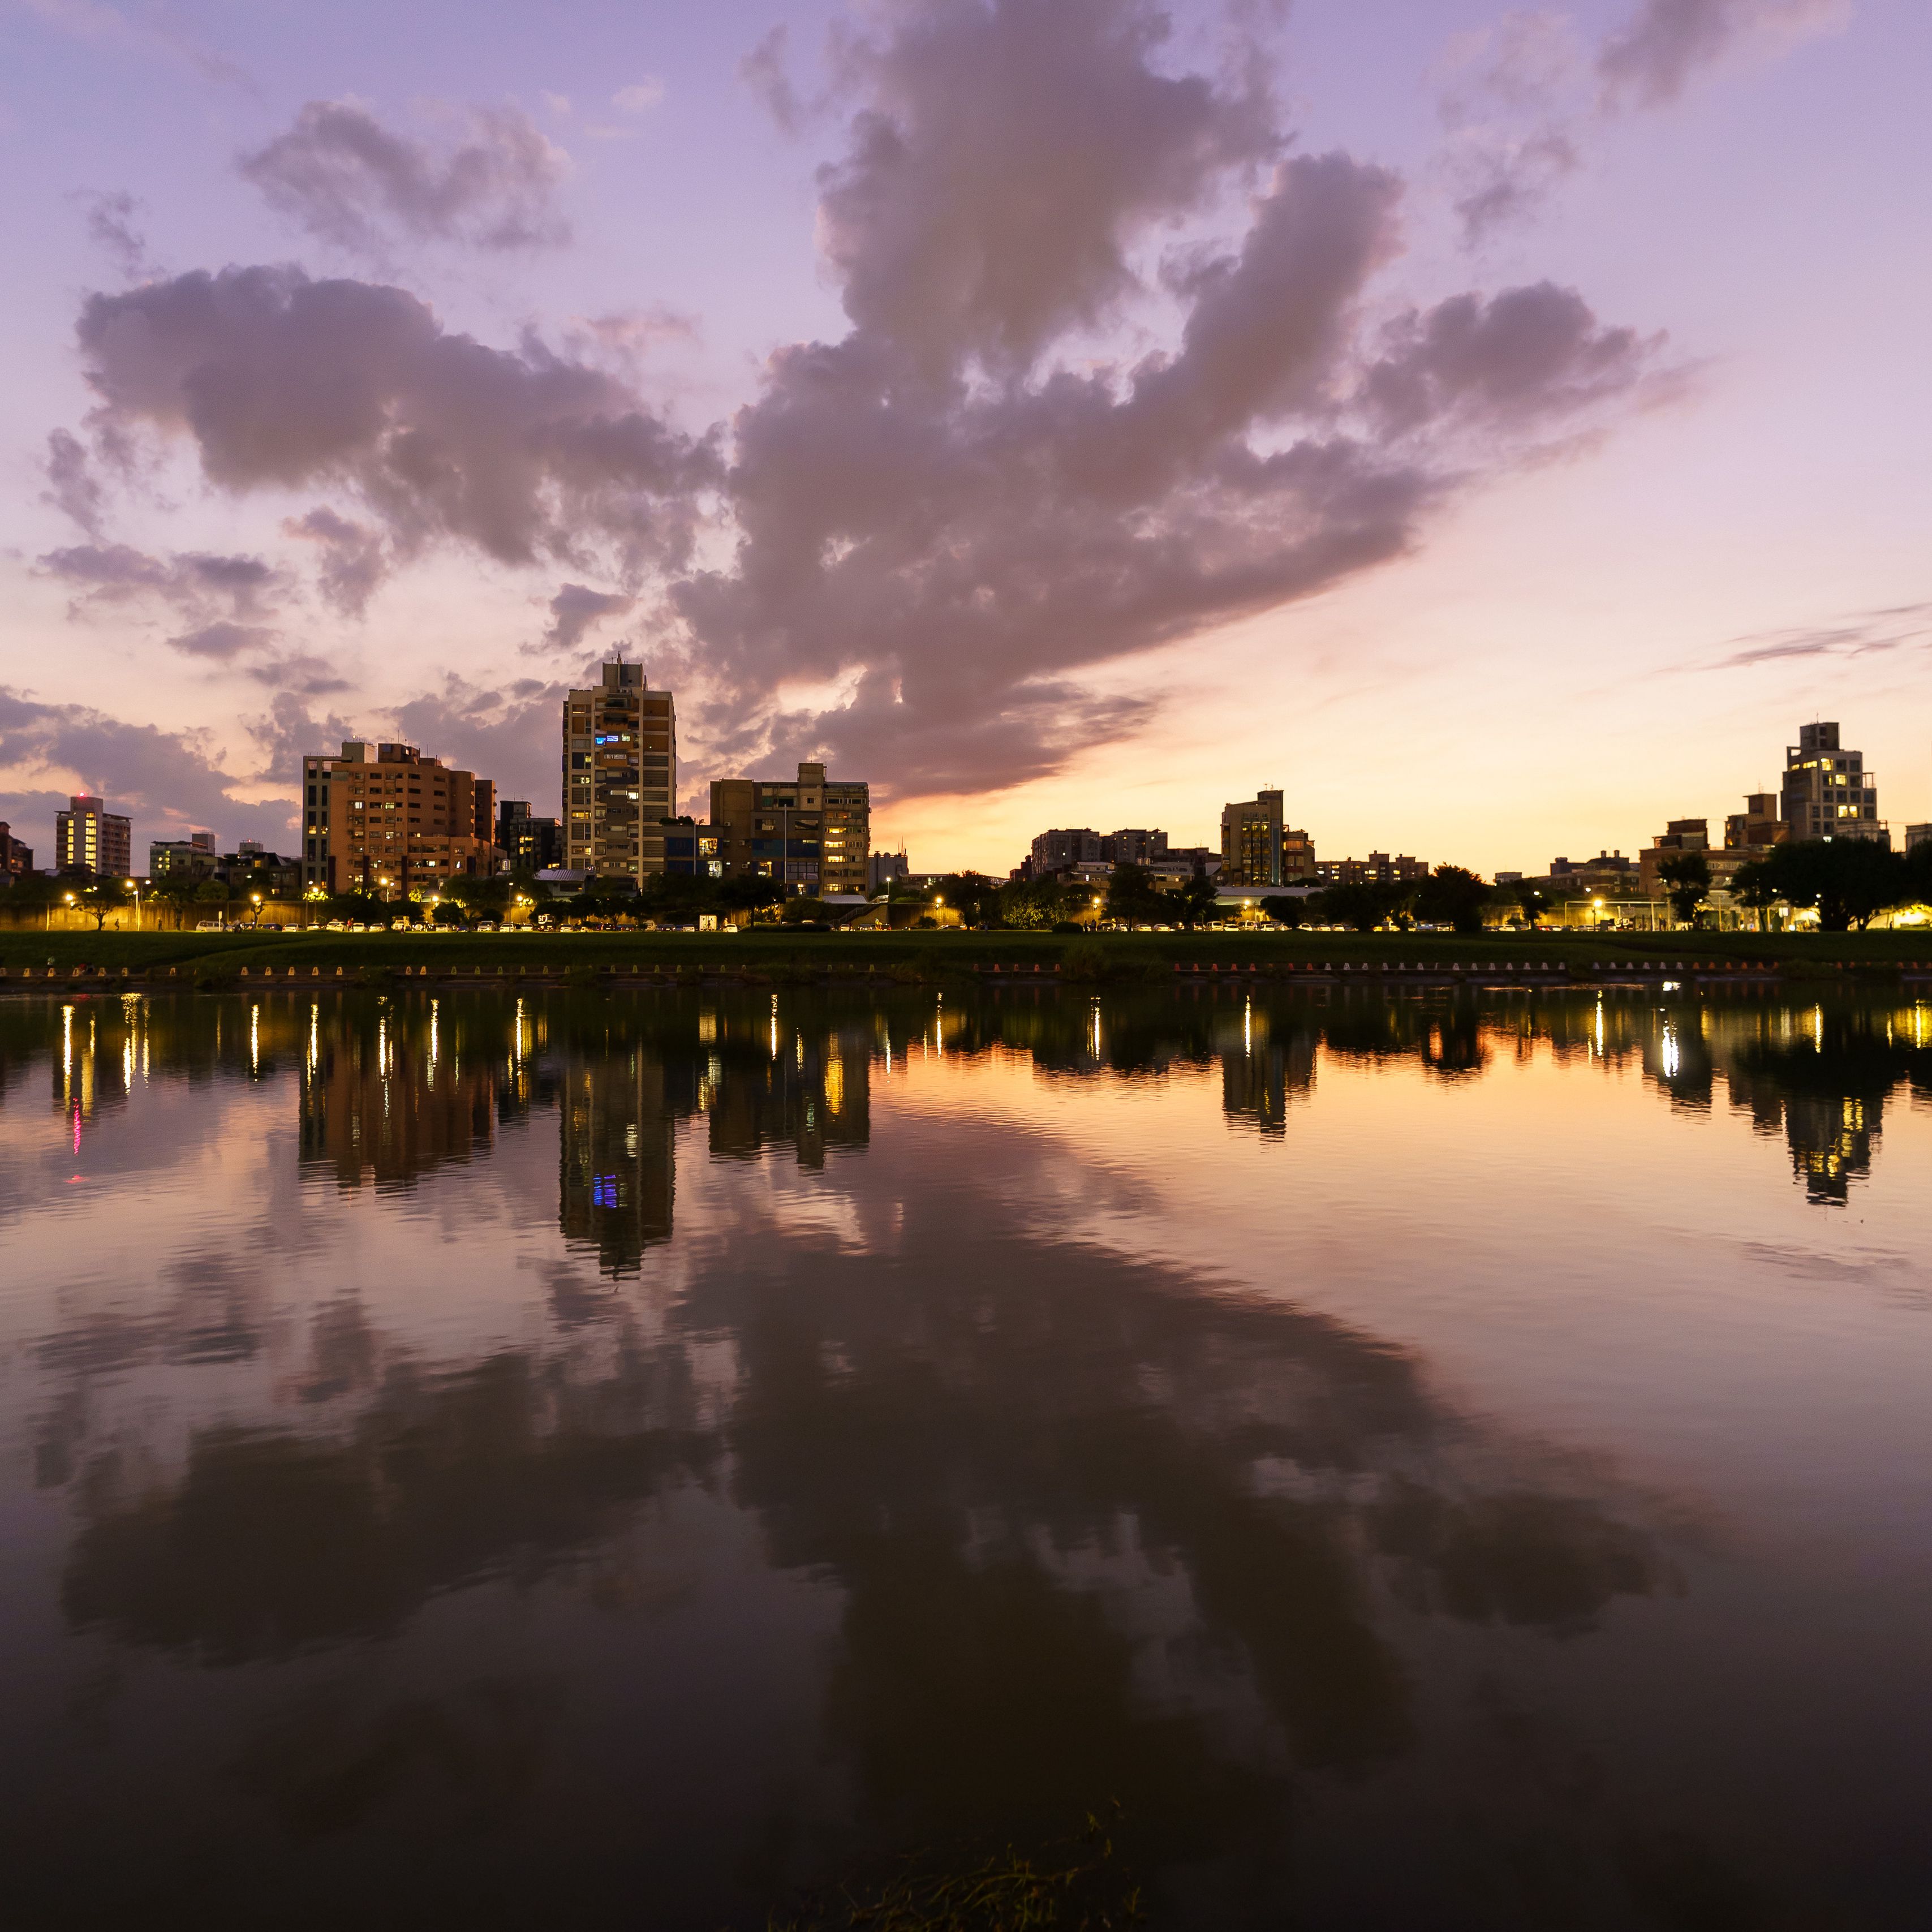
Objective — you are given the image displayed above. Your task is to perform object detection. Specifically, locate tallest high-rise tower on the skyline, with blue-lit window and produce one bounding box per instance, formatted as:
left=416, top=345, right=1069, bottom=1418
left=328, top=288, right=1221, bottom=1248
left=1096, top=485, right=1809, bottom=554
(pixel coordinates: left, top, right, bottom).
left=562, top=662, right=678, bottom=881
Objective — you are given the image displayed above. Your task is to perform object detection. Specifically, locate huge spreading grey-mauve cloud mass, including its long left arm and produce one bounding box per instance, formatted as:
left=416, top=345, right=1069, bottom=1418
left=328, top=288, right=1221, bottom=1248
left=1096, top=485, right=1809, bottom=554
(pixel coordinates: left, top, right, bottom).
left=64, top=0, right=1654, bottom=792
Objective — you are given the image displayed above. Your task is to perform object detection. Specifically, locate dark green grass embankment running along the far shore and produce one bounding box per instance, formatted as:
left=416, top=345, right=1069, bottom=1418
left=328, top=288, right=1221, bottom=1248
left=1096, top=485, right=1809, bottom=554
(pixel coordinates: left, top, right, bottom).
left=0, top=927, right=1932, bottom=983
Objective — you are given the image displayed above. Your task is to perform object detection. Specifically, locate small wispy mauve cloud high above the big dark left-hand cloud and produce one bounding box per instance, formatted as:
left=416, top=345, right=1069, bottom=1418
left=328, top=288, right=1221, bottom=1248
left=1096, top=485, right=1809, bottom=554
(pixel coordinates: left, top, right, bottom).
left=236, top=101, right=570, bottom=261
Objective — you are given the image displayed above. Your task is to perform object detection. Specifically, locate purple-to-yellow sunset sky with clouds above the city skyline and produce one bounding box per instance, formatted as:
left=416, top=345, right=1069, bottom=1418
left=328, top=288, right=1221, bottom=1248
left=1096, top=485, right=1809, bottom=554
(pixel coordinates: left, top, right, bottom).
left=0, top=0, right=1932, bottom=874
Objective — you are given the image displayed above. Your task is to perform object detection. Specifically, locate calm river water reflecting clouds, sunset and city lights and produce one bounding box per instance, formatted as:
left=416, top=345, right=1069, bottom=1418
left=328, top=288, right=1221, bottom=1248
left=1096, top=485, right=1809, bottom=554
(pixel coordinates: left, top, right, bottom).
left=0, top=991, right=1932, bottom=1932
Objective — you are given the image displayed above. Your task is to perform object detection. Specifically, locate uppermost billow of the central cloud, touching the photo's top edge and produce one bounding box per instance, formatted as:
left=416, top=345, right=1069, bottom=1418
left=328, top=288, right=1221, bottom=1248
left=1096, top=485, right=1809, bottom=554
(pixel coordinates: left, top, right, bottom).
left=819, top=0, right=1279, bottom=371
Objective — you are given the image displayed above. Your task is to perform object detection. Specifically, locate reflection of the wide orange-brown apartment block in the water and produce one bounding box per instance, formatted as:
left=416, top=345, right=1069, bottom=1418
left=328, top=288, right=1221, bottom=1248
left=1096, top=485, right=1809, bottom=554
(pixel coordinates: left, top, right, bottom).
left=299, top=1012, right=497, bottom=1188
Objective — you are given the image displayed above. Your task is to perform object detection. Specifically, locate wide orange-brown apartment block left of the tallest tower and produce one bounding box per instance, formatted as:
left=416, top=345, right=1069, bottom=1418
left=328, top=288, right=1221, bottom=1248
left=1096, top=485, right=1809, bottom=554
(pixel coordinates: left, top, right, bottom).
left=302, top=738, right=497, bottom=898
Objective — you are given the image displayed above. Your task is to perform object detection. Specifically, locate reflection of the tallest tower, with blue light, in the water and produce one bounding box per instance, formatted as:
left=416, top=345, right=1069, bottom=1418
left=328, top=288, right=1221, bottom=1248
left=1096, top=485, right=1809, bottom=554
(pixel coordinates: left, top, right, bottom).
left=557, top=1045, right=676, bottom=1275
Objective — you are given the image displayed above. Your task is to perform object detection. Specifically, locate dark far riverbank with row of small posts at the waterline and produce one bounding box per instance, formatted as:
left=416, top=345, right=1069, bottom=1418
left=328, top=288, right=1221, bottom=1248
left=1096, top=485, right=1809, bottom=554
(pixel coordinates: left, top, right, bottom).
left=0, top=927, right=1932, bottom=989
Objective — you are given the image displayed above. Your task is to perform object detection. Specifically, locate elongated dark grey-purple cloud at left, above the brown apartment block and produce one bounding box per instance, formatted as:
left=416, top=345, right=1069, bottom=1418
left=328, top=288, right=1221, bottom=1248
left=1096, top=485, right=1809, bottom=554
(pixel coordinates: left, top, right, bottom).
left=78, top=269, right=721, bottom=574
